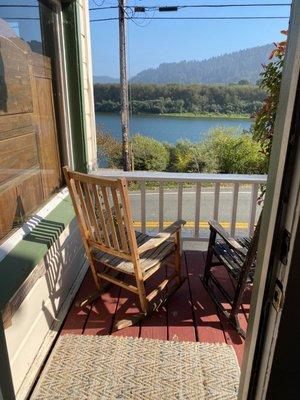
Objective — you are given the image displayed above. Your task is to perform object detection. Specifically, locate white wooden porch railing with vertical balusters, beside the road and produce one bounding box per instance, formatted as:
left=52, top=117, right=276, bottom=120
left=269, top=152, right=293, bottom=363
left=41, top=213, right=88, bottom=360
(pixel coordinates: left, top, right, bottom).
left=94, top=169, right=267, bottom=242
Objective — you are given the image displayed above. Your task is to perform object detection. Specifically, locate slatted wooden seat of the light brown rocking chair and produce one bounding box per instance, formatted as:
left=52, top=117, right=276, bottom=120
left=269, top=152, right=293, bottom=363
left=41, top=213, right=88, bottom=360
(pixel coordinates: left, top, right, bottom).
left=93, top=232, right=175, bottom=275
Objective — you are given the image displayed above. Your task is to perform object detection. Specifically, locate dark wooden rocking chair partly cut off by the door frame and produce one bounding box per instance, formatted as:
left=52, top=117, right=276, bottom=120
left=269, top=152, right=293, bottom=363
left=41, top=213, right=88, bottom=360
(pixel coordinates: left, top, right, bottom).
left=202, top=217, right=261, bottom=338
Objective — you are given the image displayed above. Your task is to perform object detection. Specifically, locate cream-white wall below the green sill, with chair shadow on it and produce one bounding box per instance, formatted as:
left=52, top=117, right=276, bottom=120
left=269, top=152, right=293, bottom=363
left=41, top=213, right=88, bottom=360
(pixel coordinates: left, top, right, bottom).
left=5, top=219, right=86, bottom=400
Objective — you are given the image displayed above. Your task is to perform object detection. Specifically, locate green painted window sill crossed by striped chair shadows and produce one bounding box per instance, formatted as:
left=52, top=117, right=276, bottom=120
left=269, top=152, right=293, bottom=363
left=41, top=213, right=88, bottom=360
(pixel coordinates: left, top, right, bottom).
left=0, top=197, right=75, bottom=309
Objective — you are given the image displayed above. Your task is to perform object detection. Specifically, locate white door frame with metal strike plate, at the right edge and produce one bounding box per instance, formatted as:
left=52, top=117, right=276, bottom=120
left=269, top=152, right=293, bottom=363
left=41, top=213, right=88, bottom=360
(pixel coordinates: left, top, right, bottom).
left=238, top=0, right=300, bottom=400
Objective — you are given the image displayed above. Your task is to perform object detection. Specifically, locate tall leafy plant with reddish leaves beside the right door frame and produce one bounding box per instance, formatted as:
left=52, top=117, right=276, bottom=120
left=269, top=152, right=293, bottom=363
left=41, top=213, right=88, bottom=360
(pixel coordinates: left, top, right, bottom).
left=252, top=31, right=288, bottom=170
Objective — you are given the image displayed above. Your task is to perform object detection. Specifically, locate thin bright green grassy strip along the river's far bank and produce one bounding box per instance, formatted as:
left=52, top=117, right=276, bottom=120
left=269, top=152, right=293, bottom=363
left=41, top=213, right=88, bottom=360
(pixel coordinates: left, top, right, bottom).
left=95, top=110, right=253, bottom=121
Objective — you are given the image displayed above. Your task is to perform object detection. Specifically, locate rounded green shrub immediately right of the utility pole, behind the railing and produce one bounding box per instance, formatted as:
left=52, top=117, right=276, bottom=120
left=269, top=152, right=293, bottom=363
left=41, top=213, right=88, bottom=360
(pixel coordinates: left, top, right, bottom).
left=131, top=135, right=169, bottom=171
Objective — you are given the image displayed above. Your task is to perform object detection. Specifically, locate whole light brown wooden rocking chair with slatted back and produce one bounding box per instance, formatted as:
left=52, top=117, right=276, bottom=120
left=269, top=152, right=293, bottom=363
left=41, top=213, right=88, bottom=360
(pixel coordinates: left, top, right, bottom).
left=63, top=167, right=185, bottom=329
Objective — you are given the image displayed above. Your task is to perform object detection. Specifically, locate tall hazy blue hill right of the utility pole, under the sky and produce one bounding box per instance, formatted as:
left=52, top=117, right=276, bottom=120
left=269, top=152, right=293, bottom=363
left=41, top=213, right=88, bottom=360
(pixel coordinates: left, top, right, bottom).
left=131, top=44, right=274, bottom=84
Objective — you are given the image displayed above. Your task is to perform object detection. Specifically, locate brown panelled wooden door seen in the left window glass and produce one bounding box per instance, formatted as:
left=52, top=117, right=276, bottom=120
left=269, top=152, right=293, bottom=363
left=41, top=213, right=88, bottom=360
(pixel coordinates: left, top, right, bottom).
left=0, top=20, right=61, bottom=240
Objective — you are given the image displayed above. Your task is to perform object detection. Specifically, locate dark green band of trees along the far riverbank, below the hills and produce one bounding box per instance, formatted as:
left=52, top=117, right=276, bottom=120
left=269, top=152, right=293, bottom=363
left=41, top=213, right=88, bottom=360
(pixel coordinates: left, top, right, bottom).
left=94, top=84, right=265, bottom=115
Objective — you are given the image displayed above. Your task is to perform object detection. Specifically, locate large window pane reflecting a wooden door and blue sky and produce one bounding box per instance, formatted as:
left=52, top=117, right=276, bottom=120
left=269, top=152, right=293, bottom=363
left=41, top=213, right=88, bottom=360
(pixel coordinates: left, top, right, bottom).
left=0, top=0, right=62, bottom=240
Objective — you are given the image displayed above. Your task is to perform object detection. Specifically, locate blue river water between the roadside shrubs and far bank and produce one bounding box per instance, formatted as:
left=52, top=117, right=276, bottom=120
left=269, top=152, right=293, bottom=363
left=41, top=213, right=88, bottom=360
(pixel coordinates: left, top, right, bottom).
left=96, top=113, right=252, bottom=144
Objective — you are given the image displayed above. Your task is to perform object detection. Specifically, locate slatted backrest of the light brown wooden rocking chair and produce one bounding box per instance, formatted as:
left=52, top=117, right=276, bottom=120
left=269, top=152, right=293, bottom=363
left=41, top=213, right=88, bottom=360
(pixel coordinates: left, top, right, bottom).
left=64, top=169, right=137, bottom=259
